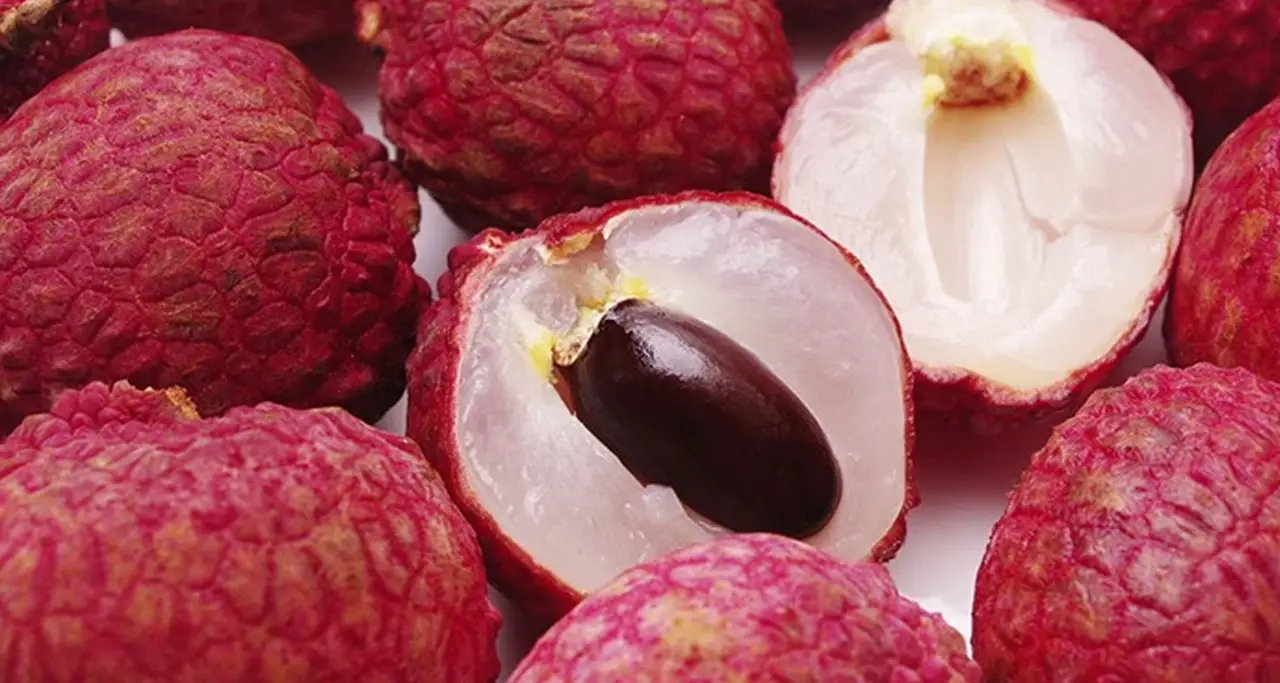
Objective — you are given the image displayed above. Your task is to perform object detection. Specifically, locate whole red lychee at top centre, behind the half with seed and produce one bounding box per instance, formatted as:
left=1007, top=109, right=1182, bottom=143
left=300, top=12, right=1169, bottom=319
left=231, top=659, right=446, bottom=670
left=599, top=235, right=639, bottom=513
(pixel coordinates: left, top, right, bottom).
left=357, top=0, right=796, bottom=230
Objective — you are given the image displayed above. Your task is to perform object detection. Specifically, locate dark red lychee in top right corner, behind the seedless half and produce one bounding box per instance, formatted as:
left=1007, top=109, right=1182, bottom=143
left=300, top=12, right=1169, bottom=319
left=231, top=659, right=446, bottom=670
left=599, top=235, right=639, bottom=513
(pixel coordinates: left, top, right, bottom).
left=1055, top=0, right=1280, bottom=164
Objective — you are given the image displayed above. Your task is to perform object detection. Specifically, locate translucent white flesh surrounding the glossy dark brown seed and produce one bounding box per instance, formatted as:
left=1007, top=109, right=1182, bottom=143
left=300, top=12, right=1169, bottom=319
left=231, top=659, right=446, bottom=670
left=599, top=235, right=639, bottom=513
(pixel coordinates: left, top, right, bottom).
left=456, top=203, right=906, bottom=591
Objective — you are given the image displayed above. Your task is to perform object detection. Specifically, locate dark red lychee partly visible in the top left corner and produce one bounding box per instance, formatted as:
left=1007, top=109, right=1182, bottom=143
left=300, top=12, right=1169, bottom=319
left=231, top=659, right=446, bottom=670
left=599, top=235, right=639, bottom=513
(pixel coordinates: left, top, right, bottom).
left=0, top=0, right=110, bottom=123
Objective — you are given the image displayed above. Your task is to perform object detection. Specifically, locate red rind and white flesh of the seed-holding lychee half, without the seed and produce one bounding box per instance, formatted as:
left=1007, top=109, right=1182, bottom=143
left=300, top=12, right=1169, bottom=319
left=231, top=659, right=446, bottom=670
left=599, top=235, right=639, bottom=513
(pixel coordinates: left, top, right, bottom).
left=408, top=193, right=915, bottom=619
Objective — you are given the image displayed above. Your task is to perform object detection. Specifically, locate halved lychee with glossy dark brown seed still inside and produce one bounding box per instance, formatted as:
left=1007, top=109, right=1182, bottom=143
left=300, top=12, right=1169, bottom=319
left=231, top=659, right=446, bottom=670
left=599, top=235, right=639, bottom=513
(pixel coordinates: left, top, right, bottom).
left=408, top=193, right=915, bottom=619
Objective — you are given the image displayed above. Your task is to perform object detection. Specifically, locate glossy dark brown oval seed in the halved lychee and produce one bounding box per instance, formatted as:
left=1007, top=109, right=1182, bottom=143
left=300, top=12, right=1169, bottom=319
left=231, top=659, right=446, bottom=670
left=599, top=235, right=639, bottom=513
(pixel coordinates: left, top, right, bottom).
left=563, top=299, right=841, bottom=538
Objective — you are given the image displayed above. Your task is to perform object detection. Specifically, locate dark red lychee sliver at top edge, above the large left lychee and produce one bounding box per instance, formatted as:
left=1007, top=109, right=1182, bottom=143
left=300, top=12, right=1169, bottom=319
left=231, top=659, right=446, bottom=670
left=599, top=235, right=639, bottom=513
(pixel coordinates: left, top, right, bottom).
left=109, top=0, right=356, bottom=46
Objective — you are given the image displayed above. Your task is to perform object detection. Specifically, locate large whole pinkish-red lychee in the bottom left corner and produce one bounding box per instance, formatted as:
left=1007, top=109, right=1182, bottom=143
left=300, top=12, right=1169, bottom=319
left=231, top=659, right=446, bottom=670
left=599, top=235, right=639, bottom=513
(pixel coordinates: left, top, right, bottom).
left=0, top=382, right=500, bottom=683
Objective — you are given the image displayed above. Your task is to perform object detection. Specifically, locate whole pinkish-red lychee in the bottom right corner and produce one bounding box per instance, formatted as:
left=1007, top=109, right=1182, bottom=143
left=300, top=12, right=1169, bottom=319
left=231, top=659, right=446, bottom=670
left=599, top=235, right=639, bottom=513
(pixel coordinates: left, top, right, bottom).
left=973, top=365, right=1280, bottom=683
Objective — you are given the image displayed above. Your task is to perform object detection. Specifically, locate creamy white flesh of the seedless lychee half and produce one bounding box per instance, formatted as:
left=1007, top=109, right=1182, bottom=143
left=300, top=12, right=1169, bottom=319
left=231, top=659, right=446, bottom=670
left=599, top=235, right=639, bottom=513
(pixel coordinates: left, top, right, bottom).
left=774, top=0, right=1193, bottom=391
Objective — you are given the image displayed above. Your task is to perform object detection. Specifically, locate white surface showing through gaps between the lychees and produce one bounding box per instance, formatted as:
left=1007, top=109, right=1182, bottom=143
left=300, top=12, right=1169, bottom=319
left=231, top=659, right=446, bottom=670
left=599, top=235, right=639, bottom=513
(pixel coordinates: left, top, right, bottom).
left=227, top=16, right=1164, bottom=674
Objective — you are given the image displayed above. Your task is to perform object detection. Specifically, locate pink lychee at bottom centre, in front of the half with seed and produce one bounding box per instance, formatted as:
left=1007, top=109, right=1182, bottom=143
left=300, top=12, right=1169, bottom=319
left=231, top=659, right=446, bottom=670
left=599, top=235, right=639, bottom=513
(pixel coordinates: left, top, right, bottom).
left=511, top=535, right=980, bottom=683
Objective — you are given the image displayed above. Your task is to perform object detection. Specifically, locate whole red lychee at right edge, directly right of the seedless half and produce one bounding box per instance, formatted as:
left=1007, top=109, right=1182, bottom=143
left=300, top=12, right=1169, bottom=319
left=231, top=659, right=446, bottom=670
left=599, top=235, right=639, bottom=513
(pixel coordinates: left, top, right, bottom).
left=1165, top=102, right=1280, bottom=380
